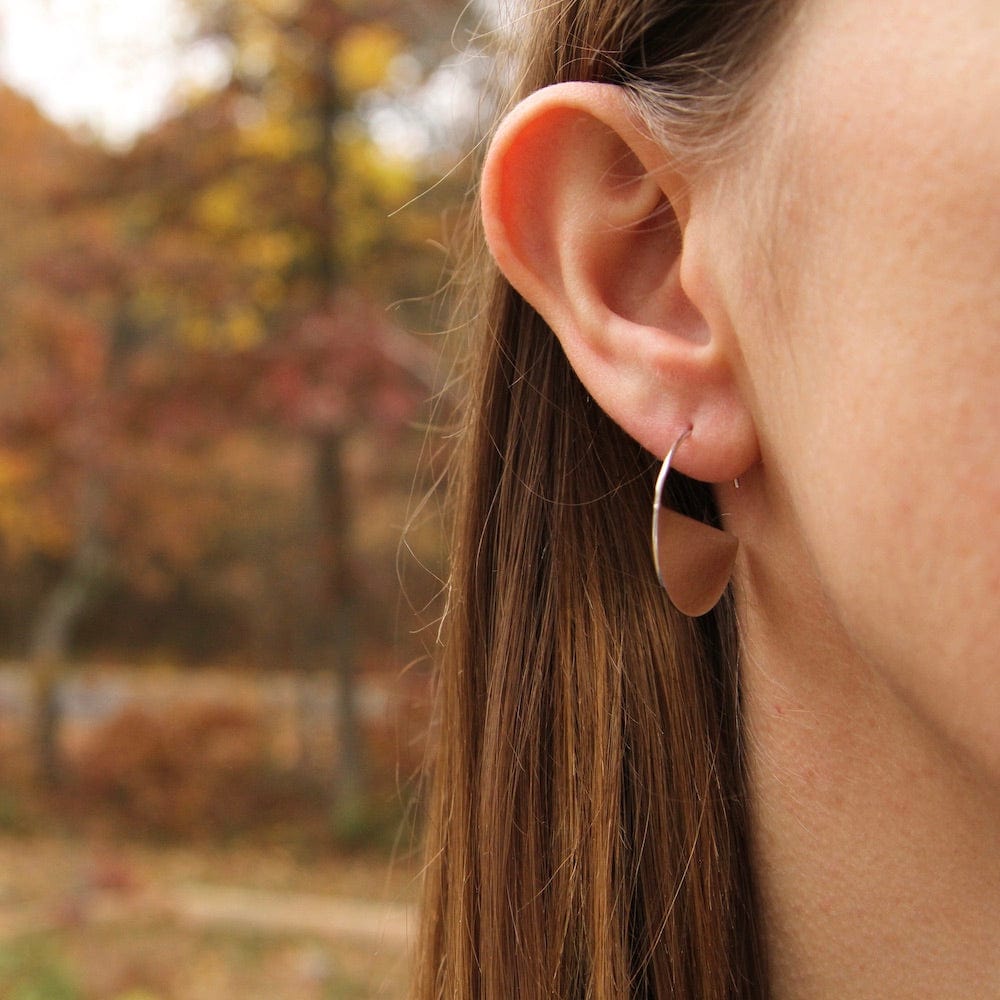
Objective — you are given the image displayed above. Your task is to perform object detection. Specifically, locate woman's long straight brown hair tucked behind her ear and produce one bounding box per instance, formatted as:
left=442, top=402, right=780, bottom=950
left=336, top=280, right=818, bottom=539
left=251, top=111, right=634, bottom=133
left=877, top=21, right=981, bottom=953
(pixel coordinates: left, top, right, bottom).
left=414, top=0, right=785, bottom=1000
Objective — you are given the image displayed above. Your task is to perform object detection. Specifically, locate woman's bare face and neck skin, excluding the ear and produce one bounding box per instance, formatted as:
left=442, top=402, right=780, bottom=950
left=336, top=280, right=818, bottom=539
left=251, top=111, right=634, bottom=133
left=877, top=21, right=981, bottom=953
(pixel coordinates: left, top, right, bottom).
left=715, top=0, right=1000, bottom=997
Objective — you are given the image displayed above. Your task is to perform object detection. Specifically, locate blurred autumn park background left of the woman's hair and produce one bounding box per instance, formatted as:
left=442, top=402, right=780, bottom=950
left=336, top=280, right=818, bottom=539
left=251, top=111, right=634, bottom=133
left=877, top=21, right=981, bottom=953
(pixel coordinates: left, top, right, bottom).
left=0, top=0, right=491, bottom=988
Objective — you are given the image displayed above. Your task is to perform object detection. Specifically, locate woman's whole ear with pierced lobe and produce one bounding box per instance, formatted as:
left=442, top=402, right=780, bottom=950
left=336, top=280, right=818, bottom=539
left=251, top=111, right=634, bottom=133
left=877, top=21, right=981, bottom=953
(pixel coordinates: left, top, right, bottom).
left=482, top=83, right=757, bottom=482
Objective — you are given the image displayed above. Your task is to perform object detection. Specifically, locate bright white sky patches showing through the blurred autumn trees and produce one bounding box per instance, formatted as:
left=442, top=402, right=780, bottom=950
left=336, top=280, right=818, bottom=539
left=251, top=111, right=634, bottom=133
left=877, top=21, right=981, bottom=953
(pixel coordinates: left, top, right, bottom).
left=0, top=0, right=488, bottom=158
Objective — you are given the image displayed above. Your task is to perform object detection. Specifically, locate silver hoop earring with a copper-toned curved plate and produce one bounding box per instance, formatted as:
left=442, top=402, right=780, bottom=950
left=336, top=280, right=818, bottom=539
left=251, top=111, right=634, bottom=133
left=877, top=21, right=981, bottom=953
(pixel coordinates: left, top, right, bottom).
left=653, top=427, right=740, bottom=618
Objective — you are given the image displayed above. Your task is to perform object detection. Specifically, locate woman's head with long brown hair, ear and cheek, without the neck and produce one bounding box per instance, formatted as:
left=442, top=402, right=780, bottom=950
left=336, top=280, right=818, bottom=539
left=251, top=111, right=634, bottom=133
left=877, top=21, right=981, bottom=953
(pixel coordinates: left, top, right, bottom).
left=421, top=0, right=1000, bottom=998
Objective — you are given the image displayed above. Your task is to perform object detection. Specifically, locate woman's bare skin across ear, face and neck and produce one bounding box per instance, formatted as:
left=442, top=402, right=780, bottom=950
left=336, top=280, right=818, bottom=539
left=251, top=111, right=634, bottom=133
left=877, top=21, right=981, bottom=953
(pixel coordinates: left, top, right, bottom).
left=483, top=0, right=1000, bottom=1000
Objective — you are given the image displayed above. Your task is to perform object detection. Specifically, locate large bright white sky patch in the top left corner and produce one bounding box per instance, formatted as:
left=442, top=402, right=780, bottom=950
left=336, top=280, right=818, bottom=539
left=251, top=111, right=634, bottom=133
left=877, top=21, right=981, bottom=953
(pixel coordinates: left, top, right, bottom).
left=0, top=0, right=227, bottom=145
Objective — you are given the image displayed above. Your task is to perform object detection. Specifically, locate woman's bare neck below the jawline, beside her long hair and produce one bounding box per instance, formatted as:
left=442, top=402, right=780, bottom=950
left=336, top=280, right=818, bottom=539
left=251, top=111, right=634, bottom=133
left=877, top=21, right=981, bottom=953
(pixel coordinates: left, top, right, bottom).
left=728, top=482, right=1000, bottom=1000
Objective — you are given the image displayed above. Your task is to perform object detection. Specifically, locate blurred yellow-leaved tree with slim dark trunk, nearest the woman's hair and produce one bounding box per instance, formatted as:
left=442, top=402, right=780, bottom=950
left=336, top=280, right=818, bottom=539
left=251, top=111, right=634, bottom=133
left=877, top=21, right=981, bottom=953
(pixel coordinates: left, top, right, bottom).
left=125, top=0, right=460, bottom=812
